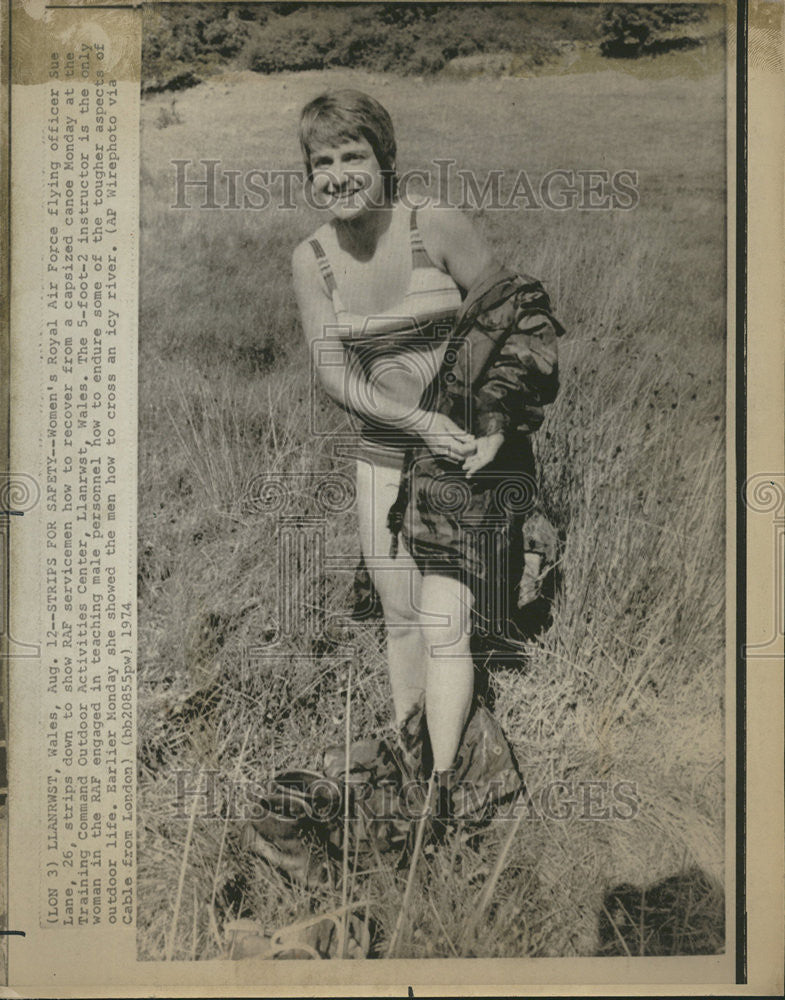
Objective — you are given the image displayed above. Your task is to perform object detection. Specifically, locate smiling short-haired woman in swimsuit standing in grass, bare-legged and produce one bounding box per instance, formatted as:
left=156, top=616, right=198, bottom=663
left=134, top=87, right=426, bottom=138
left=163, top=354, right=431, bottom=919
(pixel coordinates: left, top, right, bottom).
left=293, top=90, right=556, bottom=812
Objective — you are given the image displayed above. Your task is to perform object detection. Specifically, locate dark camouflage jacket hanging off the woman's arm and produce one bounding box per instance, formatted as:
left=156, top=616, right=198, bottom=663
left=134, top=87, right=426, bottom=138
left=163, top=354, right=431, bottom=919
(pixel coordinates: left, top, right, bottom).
left=388, top=268, right=564, bottom=587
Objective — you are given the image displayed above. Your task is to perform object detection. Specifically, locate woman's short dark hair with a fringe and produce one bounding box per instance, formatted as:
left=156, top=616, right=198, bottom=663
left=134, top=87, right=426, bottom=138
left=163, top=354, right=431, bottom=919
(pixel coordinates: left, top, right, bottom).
left=300, top=90, right=398, bottom=199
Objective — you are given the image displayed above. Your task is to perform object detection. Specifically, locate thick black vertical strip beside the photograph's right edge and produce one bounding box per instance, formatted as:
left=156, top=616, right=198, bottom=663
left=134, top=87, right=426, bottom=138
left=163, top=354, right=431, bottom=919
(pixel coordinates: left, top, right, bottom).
left=735, top=0, right=747, bottom=983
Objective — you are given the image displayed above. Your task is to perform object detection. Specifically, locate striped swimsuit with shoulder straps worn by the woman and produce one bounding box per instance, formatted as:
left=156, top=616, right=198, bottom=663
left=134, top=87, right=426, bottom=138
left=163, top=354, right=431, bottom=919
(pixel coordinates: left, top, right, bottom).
left=310, top=210, right=461, bottom=462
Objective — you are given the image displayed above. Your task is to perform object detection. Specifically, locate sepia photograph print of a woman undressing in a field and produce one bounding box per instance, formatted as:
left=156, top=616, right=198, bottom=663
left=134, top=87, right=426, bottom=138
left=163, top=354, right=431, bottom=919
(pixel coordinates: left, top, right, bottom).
left=136, top=3, right=735, bottom=962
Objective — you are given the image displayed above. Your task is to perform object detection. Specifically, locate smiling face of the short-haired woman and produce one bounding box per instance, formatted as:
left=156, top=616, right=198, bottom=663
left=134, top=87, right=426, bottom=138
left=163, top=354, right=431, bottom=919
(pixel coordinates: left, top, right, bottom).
left=311, top=138, right=385, bottom=221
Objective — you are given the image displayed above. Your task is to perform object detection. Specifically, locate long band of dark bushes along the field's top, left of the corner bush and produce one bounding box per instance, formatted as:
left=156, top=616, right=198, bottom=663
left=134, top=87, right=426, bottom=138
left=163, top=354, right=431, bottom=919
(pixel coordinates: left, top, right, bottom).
left=142, top=3, right=600, bottom=91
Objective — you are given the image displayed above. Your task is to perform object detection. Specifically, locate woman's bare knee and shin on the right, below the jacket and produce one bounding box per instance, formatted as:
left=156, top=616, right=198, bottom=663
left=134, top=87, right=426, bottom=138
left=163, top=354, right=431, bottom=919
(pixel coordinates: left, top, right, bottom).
left=420, top=574, right=474, bottom=771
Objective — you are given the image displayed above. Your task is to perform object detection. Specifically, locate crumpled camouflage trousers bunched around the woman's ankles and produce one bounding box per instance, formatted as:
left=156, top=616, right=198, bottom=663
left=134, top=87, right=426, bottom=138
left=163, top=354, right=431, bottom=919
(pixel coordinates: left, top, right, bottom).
left=243, top=705, right=522, bottom=888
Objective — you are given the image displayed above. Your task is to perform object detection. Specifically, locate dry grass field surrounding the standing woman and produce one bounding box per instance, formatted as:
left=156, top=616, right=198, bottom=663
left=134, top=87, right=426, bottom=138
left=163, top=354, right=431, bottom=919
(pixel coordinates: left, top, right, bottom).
left=138, top=53, right=726, bottom=959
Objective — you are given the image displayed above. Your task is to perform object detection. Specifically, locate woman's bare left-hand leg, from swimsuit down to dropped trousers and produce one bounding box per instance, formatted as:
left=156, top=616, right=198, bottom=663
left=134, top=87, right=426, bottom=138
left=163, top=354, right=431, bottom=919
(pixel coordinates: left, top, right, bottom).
left=357, top=458, right=426, bottom=725
